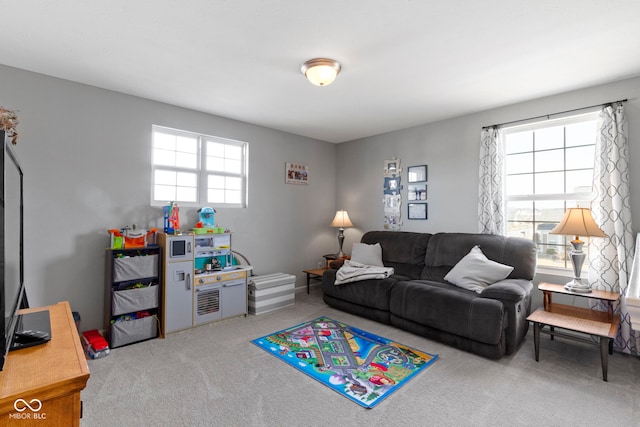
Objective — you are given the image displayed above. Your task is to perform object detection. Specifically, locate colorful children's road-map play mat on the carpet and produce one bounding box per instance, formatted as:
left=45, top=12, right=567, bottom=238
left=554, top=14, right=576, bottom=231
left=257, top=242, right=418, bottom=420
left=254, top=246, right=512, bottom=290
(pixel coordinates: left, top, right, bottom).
left=252, top=317, right=438, bottom=408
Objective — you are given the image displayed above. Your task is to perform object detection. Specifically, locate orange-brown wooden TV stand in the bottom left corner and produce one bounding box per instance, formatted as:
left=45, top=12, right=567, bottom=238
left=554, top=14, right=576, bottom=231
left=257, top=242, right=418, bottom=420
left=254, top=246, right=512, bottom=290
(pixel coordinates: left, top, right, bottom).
left=0, top=302, right=89, bottom=426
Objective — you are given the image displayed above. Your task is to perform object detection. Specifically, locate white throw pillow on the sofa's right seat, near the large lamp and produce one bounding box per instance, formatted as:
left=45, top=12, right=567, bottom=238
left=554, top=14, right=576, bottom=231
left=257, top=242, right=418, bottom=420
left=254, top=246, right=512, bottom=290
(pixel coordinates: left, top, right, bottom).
left=444, top=246, right=513, bottom=293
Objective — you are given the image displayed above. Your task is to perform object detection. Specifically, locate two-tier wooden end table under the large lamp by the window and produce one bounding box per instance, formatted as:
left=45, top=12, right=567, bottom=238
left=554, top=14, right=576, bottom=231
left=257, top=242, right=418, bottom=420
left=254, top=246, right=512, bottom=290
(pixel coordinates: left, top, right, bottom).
left=527, top=282, right=620, bottom=381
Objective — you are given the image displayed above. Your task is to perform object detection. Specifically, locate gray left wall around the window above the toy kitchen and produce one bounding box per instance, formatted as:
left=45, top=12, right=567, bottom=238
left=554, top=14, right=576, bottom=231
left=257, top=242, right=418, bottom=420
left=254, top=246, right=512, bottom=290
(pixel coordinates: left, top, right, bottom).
left=0, top=66, right=337, bottom=330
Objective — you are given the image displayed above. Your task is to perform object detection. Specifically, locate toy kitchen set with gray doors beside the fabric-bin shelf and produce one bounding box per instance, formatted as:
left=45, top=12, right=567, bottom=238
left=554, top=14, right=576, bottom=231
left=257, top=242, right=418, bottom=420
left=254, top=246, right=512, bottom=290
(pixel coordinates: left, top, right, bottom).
left=158, top=208, right=251, bottom=334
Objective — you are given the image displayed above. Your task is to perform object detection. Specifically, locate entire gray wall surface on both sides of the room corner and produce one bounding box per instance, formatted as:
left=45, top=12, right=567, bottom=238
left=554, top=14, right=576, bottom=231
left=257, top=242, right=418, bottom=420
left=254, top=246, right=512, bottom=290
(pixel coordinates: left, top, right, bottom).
left=5, top=61, right=640, bottom=329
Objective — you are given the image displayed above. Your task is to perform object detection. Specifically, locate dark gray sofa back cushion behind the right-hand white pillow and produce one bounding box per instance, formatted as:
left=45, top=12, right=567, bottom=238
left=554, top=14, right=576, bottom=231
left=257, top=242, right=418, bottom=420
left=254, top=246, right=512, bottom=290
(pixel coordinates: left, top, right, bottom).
left=421, top=233, right=537, bottom=280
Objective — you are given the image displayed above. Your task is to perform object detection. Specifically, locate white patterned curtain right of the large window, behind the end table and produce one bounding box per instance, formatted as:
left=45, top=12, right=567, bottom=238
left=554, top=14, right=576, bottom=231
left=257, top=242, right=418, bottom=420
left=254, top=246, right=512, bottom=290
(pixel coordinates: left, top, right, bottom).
left=589, top=105, right=640, bottom=354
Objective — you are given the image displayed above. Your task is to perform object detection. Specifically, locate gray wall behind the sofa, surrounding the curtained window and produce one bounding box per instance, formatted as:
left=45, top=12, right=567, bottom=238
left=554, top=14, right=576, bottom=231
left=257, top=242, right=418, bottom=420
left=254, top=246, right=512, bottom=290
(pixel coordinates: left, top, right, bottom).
left=336, top=77, right=640, bottom=310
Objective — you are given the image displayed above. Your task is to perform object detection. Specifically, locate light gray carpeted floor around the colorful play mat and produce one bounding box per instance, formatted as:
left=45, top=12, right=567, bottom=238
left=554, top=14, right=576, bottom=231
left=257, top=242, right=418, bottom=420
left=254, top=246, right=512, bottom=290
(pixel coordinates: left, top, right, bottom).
left=82, top=287, right=640, bottom=427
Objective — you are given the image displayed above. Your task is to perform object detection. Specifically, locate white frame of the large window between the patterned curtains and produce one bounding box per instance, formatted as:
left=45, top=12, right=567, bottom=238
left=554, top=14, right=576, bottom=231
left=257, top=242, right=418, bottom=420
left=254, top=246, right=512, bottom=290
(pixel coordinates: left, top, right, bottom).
left=502, top=111, right=598, bottom=271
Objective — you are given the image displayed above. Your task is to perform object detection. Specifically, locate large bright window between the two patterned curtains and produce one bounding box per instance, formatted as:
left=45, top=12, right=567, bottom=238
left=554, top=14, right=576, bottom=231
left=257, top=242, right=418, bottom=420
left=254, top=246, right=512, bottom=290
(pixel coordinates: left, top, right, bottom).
left=503, top=113, right=597, bottom=268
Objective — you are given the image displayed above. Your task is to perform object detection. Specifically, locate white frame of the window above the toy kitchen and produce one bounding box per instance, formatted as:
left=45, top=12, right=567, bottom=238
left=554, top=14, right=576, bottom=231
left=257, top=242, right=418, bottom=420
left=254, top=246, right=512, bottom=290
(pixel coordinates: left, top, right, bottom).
left=151, top=125, right=249, bottom=208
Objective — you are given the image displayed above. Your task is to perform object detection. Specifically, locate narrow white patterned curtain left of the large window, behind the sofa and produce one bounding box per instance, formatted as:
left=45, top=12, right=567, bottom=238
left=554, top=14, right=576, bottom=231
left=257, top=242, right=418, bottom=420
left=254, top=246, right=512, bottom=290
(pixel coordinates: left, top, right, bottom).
left=478, top=127, right=505, bottom=234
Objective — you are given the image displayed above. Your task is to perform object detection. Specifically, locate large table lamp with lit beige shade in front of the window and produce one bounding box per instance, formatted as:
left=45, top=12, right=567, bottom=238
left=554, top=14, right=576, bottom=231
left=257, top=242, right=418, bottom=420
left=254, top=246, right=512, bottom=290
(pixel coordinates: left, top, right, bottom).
left=549, top=208, right=607, bottom=293
